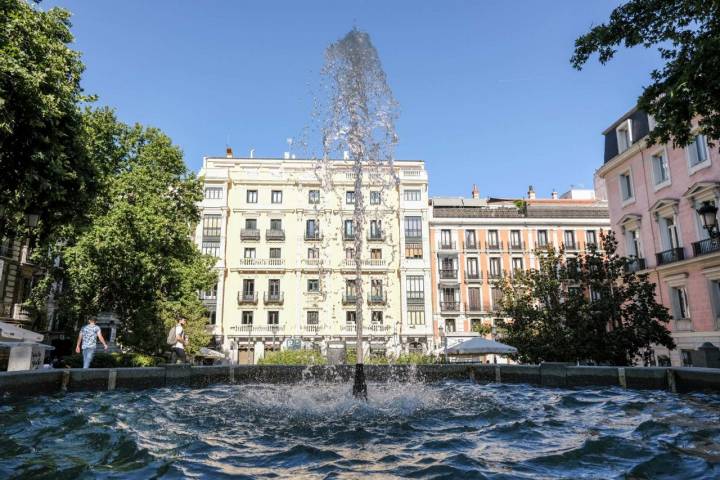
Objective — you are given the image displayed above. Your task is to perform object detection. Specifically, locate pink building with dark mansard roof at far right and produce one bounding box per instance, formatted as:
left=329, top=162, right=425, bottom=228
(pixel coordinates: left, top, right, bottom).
left=597, top=109, right=720, bottom=366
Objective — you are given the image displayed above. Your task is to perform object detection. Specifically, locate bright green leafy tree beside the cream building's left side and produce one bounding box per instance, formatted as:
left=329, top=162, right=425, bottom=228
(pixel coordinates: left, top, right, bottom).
left=34, top=110, right=217, bottom=354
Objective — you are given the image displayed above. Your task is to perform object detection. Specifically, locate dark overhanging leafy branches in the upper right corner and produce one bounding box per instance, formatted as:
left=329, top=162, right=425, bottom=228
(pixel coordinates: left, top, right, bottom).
left=571, top=0, right=720, bottom=146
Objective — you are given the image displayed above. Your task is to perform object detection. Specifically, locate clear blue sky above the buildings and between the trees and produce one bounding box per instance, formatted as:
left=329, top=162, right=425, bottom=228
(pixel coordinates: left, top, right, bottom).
left=41, top=0, right=660, bottom=196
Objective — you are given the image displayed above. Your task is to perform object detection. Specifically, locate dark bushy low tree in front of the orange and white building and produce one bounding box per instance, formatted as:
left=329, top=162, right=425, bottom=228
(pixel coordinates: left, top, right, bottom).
left=501, top=232, right=675, bottom=365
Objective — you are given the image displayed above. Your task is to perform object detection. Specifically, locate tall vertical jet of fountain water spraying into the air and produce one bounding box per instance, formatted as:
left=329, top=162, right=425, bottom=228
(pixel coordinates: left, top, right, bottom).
left=322, top=28, right=398, bottom=399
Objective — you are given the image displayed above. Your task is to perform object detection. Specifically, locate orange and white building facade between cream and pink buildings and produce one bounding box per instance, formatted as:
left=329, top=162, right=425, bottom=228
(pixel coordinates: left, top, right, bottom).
left=430, top=187, right=610, bottom=356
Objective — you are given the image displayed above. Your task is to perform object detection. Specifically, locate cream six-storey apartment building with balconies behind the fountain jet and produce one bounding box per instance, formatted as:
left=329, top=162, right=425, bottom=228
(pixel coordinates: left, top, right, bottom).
left=196, top=149, right=433, bottom=363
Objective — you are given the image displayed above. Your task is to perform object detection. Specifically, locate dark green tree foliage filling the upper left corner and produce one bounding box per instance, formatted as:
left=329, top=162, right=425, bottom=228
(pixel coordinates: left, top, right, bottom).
left=0, top=0, right=98, bottom=237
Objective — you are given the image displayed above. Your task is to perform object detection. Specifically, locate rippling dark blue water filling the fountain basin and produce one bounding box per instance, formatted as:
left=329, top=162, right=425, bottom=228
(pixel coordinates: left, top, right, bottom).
left=0, top=382, right=720, bottom=479
